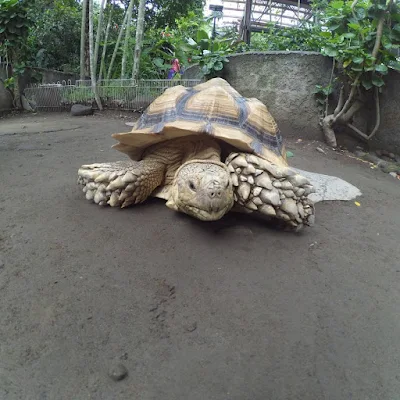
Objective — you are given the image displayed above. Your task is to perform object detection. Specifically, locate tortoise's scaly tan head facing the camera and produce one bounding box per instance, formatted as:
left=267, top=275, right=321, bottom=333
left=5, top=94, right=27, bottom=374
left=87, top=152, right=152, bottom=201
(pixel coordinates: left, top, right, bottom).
left=167, top=160, right=234, bottom=221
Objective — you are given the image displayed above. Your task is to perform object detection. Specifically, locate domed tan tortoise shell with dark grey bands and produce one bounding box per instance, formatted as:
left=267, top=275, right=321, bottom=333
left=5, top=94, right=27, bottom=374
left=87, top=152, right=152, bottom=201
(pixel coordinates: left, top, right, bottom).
left=112, top=78, right=287, bottom=165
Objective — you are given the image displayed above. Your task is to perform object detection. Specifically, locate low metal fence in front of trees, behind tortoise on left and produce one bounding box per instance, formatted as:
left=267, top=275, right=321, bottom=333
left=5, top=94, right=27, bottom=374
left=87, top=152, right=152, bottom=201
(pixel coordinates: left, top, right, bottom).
left=24, top=79, right=202, bottom=111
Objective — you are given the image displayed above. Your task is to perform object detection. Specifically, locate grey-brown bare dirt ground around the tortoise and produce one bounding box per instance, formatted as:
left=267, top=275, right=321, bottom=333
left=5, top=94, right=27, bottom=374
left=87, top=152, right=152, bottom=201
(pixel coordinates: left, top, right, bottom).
left=0, top=113, right=400, bottom=400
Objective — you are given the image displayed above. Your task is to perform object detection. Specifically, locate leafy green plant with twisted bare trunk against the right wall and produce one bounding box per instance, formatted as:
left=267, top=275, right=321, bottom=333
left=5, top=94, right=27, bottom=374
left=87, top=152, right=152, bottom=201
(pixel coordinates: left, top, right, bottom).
left=314, top=0, right=400, bottom=147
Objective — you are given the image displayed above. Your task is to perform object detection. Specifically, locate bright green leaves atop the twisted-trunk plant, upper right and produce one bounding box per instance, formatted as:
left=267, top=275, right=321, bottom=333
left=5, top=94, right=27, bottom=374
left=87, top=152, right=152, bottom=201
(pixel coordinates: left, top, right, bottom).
left=319, top=0, right=400, bottom=90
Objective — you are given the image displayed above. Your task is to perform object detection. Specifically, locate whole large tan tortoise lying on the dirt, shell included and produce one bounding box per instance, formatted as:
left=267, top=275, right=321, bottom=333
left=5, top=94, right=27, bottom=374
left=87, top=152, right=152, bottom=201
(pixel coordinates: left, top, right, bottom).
left=78, top=78, right=315, bottom=230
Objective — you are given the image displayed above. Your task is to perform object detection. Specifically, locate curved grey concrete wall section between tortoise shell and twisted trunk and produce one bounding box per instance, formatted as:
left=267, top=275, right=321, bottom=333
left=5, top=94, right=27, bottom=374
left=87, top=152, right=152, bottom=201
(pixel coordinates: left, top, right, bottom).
left=184, top=51, right=332, bottom=139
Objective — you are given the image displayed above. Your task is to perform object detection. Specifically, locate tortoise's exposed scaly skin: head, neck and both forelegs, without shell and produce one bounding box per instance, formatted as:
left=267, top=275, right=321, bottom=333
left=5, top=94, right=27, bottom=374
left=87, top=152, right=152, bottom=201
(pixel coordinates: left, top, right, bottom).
left=78, top=135, right=315, bottom=229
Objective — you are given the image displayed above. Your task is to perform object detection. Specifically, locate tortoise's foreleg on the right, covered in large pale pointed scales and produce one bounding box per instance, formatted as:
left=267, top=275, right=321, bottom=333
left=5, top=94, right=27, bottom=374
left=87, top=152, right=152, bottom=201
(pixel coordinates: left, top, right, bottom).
left=226, top=153, right=315, bottom=228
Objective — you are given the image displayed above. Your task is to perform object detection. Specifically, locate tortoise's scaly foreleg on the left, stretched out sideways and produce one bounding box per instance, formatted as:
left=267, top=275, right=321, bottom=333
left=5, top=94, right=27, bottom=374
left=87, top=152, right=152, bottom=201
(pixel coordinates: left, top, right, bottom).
left=78, top=160, right=165, bottom=208
